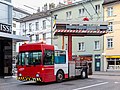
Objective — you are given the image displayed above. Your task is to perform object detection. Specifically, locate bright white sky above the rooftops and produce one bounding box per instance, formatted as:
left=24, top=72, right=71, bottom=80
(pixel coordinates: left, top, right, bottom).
left=12, top=0, right=63, bottom=11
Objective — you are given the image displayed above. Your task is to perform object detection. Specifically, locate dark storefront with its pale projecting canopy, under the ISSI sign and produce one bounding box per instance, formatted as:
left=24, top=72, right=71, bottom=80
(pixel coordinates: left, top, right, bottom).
left=0, top=32, right=29, bottom=78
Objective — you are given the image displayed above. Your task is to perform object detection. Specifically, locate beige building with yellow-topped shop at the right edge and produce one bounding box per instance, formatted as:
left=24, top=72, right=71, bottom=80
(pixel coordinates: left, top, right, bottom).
left=103, top=0, right=120, bottom=71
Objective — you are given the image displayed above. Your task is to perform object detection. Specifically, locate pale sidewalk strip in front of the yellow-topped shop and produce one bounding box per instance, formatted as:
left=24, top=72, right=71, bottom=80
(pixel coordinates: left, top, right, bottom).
left=93, top=71, right=120, bottom=76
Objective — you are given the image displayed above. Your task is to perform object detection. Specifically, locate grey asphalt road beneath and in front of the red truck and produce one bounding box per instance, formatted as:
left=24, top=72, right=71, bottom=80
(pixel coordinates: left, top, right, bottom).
left=0, top=75, right=120, bottom=90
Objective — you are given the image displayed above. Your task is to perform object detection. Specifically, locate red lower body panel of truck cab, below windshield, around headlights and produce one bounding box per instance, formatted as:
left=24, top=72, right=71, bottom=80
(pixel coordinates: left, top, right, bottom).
left=18, top=65, right=56, bottom=82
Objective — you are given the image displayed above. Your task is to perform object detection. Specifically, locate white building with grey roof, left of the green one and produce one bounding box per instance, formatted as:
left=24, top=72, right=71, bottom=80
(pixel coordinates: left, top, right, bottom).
left=20, top=11, right=52, bottom=44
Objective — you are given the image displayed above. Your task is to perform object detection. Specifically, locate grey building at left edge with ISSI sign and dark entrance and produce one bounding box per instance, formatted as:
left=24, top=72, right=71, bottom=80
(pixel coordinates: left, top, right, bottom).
left=0, top=0, right=12, bottom=77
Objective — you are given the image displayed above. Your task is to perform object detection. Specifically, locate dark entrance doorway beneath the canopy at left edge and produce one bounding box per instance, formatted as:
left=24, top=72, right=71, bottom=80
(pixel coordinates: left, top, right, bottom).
left=0, top=38, right=12, bottom=77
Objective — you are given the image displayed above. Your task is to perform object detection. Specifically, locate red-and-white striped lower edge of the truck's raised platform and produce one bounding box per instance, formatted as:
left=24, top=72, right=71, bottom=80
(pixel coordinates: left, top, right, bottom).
left=54, top=29, right=107, bottom=36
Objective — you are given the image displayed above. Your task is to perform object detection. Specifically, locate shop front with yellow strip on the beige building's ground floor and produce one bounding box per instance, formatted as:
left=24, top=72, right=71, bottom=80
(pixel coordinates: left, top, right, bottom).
left=106, top=56, right=120, bottom=71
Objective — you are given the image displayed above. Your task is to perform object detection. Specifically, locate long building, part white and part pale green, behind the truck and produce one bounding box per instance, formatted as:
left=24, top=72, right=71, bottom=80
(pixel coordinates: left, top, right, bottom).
left=20, top=0, right=104, bottom=72
